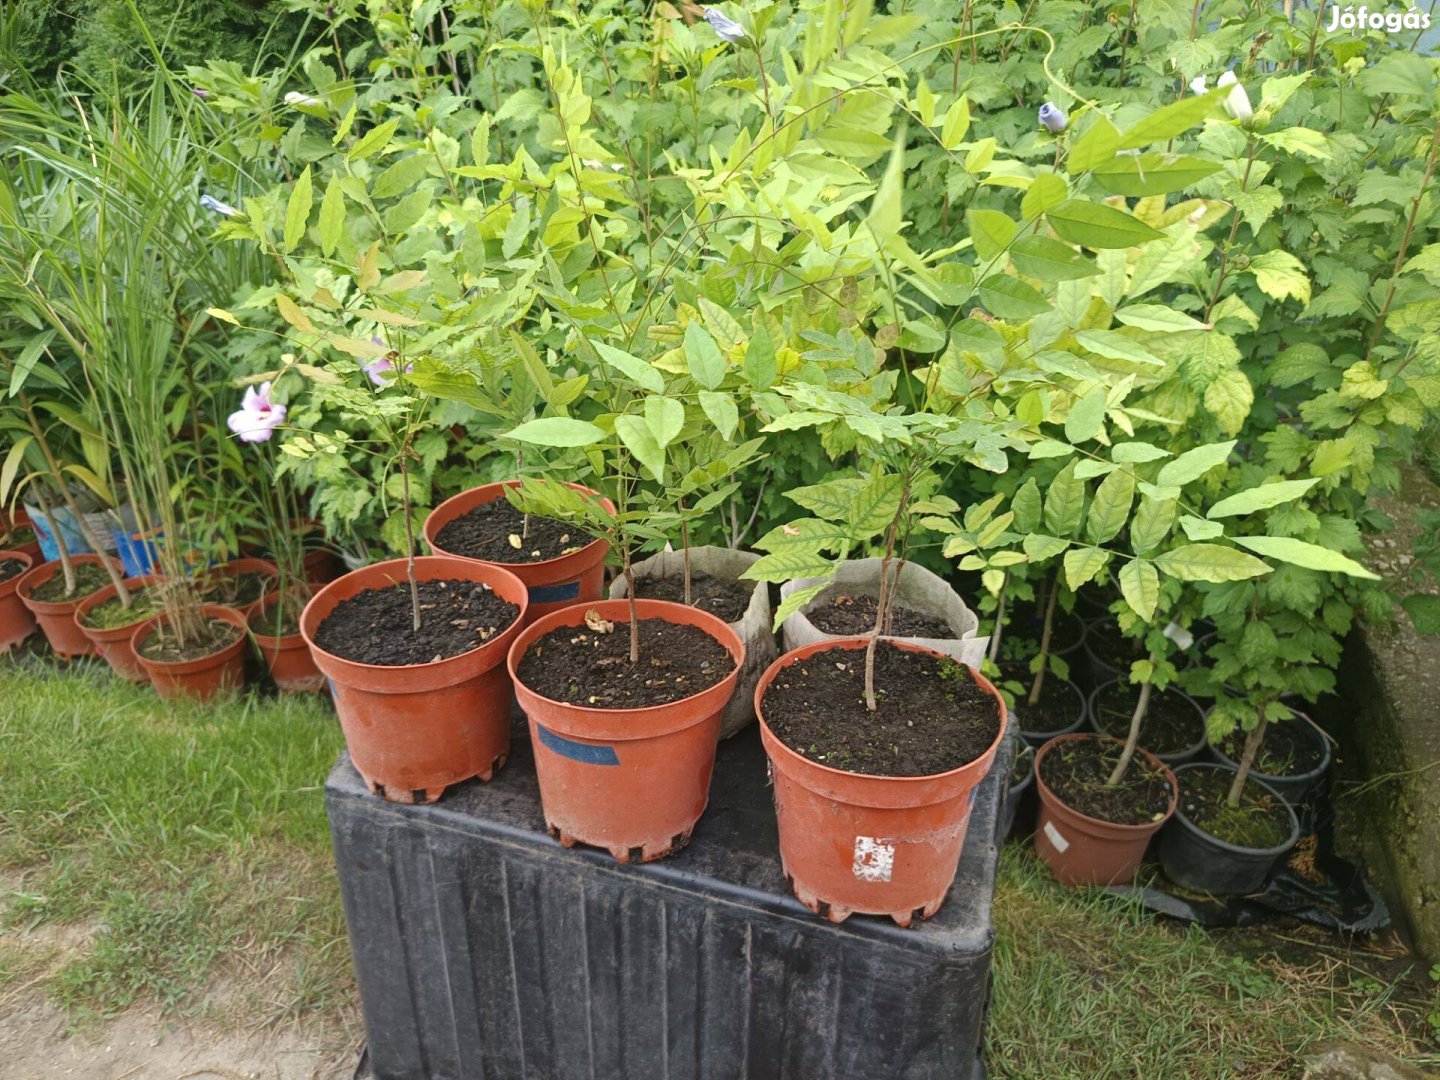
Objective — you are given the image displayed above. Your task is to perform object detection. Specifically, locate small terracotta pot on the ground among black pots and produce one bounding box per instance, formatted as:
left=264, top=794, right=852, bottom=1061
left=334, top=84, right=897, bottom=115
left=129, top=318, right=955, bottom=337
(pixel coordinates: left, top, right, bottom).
left=1035, top=734, right=1178, bottom=886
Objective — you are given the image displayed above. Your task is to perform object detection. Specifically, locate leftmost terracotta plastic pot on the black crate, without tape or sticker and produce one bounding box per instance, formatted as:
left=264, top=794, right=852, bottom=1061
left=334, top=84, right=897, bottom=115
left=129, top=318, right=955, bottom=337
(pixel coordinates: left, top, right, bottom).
left=300, top=556, right=527, bottom=802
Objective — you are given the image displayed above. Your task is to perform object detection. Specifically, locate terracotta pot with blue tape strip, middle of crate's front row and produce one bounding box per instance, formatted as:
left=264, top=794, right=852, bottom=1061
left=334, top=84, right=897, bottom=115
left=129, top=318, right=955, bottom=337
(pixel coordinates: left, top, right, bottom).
left=508, top=599, right=744, bottom=863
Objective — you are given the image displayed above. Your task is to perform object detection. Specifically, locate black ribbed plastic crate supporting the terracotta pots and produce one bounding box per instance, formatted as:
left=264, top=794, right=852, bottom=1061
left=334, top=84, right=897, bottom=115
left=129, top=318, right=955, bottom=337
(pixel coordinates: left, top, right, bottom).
left=325, top=723, right=1014, bottom=1080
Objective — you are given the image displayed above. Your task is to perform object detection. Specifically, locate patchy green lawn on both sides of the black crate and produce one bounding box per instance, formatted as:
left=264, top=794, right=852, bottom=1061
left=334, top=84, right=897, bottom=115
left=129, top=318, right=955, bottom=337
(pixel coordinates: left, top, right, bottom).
left=0, top=660, right=1440, bottom=1080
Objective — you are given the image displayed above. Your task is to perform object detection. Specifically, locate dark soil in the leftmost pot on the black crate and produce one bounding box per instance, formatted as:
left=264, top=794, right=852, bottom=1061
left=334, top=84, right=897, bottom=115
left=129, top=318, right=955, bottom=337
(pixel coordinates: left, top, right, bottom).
left=315, top=580, right=520, bottom=667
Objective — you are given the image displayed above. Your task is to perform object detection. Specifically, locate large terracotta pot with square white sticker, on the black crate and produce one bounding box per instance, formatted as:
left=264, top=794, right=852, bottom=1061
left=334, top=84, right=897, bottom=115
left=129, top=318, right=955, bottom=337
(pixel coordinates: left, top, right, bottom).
left=755, top=638, right=1007, bottom=926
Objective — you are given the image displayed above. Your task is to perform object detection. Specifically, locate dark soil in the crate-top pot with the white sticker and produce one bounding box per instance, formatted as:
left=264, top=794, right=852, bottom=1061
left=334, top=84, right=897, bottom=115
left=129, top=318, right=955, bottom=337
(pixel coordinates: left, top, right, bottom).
left=763, top=642, right=999, bottom=776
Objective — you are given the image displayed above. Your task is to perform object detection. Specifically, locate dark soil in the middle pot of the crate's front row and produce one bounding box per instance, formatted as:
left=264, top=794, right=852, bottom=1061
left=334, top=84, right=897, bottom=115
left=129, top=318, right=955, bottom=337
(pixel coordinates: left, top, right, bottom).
left=518, top=618, right=734, bottom=708
